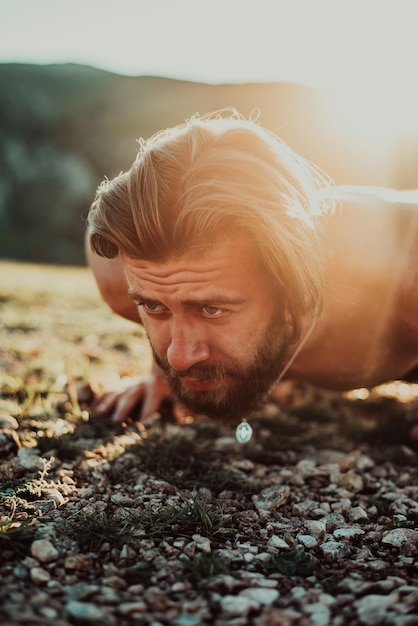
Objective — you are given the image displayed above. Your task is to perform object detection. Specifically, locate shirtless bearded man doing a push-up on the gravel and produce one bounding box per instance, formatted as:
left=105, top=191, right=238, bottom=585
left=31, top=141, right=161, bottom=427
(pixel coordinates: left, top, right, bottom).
left=87, top=111, right=418, bottom=421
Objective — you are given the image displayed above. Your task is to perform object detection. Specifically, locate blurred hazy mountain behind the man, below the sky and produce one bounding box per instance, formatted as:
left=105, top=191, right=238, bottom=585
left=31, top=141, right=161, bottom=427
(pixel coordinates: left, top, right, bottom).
left=0, top=64, right=418, bottom=264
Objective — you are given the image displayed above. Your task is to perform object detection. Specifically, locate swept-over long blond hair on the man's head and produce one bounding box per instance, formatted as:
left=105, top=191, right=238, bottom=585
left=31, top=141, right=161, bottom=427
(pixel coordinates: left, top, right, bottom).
left=88, top=109, right=330, bottom=341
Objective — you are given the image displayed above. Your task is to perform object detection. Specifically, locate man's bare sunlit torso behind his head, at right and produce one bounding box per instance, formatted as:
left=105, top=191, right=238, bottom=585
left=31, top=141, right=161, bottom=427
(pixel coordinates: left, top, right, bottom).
left=288, top=187, right=418, bottom=389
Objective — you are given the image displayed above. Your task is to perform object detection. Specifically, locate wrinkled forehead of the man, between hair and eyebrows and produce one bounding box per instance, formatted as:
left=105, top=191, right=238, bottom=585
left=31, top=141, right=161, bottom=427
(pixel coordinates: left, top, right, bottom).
left=122, top=236, right=270, bottom=296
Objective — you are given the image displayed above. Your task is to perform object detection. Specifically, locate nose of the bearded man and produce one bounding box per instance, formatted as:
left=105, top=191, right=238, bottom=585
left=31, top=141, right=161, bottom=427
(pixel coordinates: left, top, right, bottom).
left=167, top=324, right=210, bottom=372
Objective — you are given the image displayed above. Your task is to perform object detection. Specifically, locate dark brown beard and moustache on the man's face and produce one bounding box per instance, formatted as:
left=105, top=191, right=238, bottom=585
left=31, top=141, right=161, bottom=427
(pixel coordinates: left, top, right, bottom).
left=151, top=317, right=289, bottom=421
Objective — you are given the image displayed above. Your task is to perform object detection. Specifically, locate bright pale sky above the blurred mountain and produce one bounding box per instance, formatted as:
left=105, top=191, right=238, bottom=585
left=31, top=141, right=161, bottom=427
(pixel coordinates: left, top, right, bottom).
left=0, top=0, right=418, bottom=135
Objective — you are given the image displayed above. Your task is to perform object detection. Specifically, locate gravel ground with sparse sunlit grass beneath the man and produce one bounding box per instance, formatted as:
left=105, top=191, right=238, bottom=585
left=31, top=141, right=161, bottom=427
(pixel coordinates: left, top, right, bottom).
left=0, top=260, right=418, bottom=626
